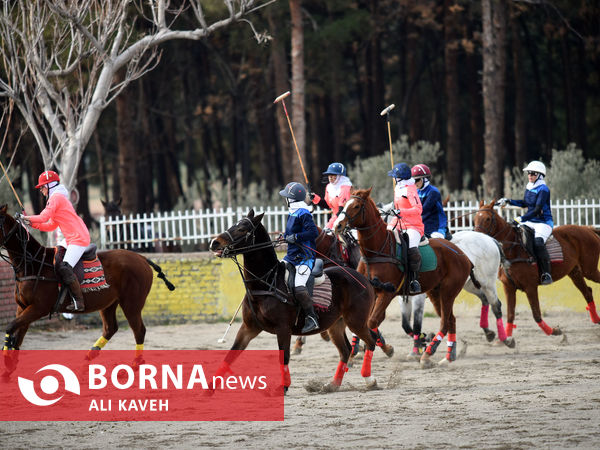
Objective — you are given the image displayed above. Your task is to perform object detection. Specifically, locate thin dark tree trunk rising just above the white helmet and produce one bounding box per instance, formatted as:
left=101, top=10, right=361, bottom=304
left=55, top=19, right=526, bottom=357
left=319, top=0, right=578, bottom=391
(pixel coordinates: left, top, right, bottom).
left=511, top=8, right=527, bottom=167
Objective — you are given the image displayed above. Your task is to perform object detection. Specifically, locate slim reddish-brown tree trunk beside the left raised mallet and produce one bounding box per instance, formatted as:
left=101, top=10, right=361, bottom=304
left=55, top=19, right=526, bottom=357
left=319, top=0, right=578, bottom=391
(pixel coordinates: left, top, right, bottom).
left=290, top=0, right=306, bottom=183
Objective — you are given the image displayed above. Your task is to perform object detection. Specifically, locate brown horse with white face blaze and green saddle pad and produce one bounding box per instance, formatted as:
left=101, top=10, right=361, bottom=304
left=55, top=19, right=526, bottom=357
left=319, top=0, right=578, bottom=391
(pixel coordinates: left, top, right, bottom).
left=334, top=189, right=473, bottom=367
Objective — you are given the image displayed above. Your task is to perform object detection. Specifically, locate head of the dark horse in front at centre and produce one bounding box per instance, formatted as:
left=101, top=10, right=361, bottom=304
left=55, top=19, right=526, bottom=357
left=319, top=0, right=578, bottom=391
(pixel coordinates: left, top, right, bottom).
left=209, top=209, right=270, bottom=257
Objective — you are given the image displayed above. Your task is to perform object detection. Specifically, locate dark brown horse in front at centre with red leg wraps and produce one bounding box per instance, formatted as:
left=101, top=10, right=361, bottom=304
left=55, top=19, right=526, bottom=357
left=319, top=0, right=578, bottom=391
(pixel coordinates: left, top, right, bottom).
left=209, top=210, right=377, bottom=392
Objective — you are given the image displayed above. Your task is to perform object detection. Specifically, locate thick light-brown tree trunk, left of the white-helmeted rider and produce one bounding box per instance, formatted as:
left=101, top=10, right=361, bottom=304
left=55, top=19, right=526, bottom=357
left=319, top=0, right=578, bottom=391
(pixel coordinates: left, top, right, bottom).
left=482, top=0, right=506, bottom=197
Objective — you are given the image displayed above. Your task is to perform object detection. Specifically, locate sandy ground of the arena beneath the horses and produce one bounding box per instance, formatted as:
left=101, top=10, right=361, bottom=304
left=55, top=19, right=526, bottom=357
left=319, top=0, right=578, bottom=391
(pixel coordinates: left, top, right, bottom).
left=0, top=303, right=600, bottom=449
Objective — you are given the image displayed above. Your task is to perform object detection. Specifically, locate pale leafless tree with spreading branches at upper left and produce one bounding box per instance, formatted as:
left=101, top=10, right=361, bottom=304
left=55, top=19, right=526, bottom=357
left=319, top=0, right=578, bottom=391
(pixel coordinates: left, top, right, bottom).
left=0, top=0, right=274, bottom=189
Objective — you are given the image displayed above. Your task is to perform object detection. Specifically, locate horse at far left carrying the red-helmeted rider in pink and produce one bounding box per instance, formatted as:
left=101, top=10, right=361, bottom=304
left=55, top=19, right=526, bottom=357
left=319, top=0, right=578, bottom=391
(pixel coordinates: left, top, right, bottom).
left=0, top=205, right=175, bottom=377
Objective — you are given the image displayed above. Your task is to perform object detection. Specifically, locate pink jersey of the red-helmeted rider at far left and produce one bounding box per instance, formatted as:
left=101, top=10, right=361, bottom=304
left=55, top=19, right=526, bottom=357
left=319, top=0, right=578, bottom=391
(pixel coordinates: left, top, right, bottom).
left=29, top=192, right=90, bottom=247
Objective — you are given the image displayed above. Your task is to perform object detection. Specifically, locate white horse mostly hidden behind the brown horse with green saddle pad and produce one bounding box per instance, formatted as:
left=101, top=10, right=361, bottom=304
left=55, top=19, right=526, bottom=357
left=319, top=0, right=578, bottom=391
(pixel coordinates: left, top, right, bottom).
left=398, top=231, right=515, bottom=358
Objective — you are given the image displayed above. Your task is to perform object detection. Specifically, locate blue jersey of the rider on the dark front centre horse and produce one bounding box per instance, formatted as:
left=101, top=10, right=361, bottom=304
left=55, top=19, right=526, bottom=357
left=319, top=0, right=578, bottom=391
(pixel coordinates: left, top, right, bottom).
left=283, top=208, right=319, bottom=269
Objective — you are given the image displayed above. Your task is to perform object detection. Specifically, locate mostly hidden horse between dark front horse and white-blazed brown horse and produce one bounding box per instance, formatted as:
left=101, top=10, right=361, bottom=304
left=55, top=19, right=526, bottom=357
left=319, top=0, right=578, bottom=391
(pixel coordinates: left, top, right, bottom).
left=292, top=227, right=394, bottom=358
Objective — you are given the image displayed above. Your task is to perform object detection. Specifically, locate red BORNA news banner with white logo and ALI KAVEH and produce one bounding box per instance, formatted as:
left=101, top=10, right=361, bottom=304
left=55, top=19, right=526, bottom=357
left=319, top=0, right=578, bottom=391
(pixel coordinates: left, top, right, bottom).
left=0, top=350, right=284, bottom=421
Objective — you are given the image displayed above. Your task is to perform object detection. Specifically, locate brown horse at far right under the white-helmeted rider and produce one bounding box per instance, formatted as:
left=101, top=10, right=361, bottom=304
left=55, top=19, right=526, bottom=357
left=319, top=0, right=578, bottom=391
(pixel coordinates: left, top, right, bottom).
left=473, top=200, right=600, bottom=336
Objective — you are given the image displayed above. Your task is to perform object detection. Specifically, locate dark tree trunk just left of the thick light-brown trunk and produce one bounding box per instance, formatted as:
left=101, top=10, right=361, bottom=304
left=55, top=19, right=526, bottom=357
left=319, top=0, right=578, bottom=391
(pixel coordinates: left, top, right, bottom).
left=444, top=0, right=462, bottom=191
